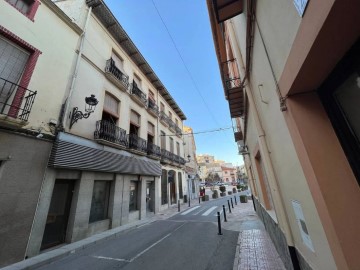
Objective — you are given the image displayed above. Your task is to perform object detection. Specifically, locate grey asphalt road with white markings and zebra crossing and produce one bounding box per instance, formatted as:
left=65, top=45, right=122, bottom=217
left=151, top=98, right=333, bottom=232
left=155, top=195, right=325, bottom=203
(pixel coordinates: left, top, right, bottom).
left=39, top=197, right=239, bottom=270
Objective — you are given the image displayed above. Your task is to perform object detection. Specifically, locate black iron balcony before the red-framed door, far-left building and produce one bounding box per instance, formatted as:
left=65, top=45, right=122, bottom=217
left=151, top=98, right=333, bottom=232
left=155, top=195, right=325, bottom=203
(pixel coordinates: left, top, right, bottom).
left=0, top=78, right=37, bottom=128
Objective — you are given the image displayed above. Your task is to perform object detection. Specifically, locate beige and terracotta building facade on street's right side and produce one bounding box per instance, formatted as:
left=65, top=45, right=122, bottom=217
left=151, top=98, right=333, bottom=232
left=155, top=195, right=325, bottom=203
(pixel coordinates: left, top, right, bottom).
left=208, top=0, right=360, bottom=269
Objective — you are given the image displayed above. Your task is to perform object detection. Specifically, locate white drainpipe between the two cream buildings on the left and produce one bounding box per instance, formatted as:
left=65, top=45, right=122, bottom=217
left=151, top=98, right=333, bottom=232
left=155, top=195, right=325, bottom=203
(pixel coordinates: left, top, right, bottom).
left=61, top=7, right=92, bottom=129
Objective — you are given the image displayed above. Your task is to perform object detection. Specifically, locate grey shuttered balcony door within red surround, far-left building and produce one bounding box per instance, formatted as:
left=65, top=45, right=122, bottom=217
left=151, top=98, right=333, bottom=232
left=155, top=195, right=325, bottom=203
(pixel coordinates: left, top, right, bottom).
left=0, top=36, right=29, bottom=114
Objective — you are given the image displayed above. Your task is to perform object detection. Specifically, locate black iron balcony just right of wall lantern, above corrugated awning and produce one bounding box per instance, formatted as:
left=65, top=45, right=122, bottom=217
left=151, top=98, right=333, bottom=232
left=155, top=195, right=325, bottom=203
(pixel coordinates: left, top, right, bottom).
left=94, top=120, right=129, bottom=149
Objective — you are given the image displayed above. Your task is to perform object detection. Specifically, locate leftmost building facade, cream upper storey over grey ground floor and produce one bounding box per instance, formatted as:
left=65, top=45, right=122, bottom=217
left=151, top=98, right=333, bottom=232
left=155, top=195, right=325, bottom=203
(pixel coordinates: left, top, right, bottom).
left=0, top=0, right=82, bottom=267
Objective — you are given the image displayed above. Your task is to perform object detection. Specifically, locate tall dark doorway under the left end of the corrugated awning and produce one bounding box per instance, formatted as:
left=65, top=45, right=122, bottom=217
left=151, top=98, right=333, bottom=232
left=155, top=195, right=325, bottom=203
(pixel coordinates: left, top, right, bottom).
left=40, top=180, right=75, bottom=250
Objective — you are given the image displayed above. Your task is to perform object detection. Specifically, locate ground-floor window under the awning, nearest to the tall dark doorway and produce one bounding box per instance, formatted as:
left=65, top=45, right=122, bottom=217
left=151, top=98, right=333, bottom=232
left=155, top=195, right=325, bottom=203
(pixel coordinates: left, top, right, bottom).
left=89, top=181, right=110, bottom=223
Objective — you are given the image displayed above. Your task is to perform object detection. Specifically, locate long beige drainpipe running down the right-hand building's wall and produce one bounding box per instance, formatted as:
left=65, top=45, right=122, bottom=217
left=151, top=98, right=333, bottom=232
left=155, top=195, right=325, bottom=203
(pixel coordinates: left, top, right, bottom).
left=229, top=20, right=294, bottom=246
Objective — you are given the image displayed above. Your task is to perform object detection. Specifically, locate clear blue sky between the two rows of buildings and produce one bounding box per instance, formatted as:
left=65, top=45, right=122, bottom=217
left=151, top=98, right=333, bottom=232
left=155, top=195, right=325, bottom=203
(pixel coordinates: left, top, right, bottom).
left=105, top=0, right=243, bottom=165
